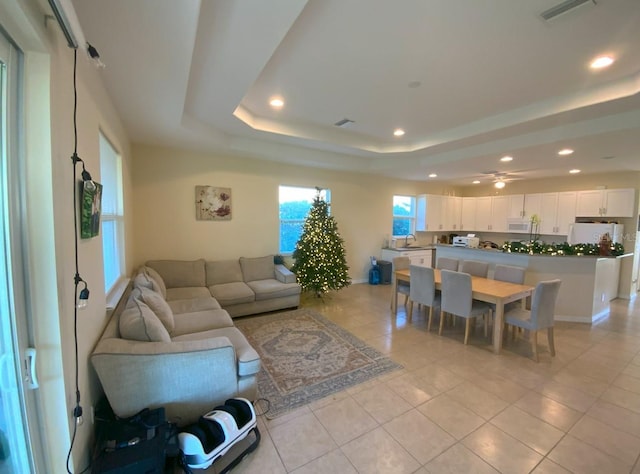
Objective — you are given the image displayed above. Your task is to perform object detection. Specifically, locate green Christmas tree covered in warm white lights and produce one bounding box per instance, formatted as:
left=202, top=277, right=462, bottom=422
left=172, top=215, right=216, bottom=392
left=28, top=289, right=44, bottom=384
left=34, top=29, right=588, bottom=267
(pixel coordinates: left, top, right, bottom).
left=291, top=188, right=351, bottom=296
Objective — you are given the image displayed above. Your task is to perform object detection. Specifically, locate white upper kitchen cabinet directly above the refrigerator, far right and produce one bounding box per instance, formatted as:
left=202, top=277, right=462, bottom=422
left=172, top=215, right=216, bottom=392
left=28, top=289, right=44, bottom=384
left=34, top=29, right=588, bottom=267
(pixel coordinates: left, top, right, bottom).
left=576, top=189, right=636, bottom=217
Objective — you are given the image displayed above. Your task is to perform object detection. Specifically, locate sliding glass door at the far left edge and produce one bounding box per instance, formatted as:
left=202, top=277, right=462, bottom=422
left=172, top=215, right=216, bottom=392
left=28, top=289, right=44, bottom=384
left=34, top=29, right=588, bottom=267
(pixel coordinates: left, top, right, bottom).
left=0, top=26, right=36, bottom=474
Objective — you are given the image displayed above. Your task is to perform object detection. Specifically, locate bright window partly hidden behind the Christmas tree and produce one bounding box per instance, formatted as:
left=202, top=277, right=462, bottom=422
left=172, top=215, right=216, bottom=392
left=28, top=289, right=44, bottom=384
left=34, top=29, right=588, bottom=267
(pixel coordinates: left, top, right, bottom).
left=280, top=186, right=331, bottom=254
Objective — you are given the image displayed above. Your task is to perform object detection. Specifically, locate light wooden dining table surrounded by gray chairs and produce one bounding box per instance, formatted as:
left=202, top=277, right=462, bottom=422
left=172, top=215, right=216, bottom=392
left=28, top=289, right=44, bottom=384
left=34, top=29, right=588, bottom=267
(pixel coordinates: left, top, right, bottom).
left=391, top=269, right=534, bottom=354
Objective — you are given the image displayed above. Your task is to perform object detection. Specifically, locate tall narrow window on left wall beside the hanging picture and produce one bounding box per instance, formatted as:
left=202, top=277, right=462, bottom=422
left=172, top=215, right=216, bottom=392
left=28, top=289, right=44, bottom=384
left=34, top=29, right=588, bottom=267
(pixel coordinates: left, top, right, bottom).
left=100, top=134, right=125, bottom=300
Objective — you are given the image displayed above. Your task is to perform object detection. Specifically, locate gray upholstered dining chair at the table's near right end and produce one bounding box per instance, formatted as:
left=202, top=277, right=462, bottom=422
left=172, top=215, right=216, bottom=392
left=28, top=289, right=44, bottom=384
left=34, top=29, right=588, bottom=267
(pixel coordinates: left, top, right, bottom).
left=504, top=279, right=561, bottom=362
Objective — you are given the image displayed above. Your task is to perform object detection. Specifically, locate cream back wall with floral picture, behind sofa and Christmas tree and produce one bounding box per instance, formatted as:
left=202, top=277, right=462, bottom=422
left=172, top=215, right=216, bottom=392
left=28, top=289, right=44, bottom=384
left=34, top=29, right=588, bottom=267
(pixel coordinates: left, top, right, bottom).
left=133, top=145, right=448, bottom=281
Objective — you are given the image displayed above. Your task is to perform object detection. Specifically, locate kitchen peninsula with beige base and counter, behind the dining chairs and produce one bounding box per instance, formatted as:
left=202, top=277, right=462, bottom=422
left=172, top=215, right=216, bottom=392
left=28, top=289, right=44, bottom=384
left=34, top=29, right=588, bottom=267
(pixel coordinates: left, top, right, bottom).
left=437, top=244, right=633, bottom=323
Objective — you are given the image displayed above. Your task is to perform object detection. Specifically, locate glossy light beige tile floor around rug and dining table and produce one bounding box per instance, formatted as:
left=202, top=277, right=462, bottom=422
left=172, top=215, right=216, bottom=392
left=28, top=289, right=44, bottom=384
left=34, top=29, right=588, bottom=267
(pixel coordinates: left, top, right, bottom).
left=204, top=284, right=640, bottom=474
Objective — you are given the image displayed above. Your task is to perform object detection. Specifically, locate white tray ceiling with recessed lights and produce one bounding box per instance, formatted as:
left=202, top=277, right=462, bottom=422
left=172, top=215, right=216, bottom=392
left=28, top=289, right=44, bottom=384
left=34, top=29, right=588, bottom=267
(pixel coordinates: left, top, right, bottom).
left=73, top=0, right=640, bottom=185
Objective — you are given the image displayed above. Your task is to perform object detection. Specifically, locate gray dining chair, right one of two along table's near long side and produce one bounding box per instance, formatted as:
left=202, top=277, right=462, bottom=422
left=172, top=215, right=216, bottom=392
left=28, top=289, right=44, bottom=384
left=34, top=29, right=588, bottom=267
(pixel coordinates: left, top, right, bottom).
left=438, top=269, right=491, bottom=344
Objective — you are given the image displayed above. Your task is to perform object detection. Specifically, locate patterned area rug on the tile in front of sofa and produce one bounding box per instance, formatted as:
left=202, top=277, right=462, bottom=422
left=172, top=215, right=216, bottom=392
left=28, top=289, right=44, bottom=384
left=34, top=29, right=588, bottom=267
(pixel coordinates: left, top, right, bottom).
left=234, top=309, right=402, bottom=418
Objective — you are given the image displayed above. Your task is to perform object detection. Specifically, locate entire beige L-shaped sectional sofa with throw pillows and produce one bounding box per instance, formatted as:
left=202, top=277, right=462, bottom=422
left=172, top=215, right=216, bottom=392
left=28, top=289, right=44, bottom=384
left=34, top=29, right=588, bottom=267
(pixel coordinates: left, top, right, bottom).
left=91, top=256, right=300, bottom=425
